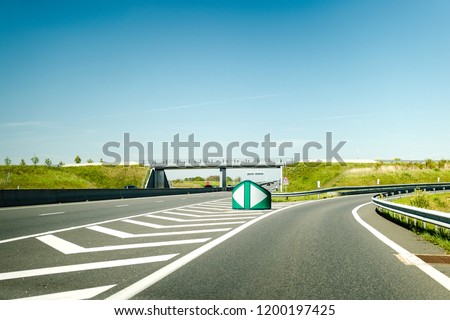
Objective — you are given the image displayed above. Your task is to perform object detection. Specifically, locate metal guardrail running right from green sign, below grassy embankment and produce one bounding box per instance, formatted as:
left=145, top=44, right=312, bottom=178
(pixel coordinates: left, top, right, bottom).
left=272, top=183, right=450, bottom=198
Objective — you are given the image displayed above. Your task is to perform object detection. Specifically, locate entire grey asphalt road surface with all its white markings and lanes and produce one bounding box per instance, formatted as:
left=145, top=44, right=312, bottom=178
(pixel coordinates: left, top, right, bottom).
left=0, top=193, right=450, bottom=300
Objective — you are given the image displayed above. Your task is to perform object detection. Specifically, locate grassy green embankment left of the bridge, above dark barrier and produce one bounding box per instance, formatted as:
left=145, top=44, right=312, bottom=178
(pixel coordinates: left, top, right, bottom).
left=0, top=165, right=148, bottom=189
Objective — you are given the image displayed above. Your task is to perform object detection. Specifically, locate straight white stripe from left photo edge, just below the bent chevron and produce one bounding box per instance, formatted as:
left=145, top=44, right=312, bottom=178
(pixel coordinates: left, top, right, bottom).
left=0, top=253, right=178, bottom=281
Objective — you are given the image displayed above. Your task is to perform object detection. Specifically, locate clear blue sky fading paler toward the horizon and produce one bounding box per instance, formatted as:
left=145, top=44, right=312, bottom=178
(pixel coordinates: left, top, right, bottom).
left=0, top=0, right=450, bottom=163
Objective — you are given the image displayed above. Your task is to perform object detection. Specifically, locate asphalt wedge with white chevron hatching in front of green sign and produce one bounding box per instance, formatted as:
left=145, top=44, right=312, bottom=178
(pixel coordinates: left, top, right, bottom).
left=0, top=193, right=294, bottom=299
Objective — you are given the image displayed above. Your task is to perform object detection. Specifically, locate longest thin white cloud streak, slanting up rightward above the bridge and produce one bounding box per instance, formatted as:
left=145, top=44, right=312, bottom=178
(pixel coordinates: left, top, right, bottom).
left=89, top=94, right=283, bottom=119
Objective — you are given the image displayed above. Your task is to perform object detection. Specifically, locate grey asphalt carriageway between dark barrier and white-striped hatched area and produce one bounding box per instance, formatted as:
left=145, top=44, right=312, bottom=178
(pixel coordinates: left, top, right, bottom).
left=0, top=192, right=230, bottom=243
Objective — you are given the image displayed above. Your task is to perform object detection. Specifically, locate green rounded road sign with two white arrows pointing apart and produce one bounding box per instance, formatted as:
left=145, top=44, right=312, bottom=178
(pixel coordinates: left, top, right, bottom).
left=232, top=180, right=272, bottom=210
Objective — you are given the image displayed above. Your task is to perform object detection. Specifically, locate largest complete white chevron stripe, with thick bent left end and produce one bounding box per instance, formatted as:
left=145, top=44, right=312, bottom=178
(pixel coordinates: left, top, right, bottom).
left=36, top=234, right=211, bottom=254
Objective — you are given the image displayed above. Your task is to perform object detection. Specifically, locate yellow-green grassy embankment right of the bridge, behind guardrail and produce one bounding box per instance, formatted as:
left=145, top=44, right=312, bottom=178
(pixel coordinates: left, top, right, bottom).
left=284, top=160, right=450, bottom=192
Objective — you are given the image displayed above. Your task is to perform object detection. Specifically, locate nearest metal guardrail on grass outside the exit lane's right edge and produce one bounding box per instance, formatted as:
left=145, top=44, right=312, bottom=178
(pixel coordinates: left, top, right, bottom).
left=372, top=194, right=450, bottom=229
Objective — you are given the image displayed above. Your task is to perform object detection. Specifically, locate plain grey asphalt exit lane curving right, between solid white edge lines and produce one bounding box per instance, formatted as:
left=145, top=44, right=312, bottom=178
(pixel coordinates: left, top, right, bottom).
left=129, top=195, right=450, bottom=300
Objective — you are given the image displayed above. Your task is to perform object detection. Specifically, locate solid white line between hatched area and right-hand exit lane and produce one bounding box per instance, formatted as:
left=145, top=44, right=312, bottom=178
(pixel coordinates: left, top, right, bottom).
left=106, top=202, right=308, bottom=300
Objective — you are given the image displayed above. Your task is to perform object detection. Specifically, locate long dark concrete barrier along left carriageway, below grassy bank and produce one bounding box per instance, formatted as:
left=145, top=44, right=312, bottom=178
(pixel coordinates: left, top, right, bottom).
left=0, top=188, right=220, bottom=207
